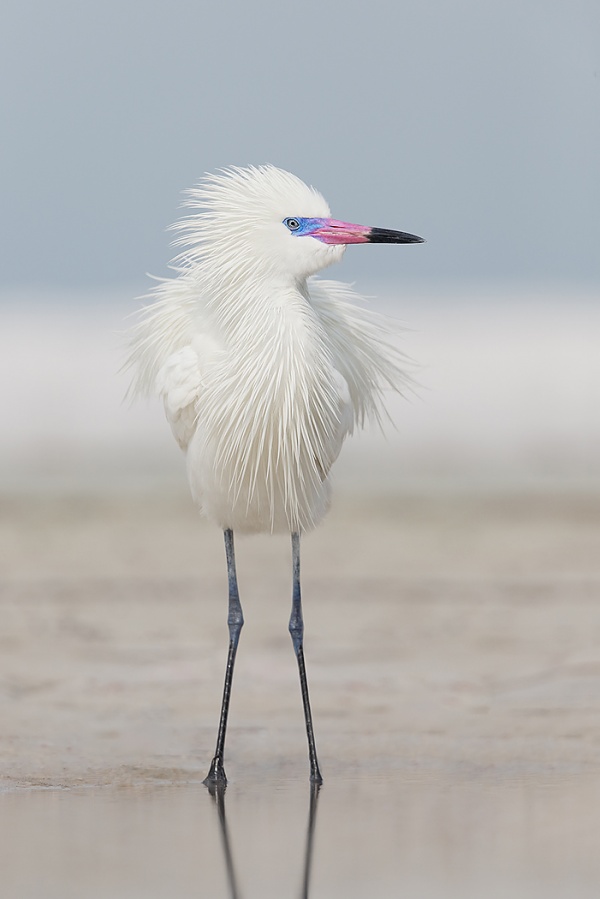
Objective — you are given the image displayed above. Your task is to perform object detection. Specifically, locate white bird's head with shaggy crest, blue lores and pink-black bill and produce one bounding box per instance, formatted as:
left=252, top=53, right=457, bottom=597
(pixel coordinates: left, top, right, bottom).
left=170, top=165, right=423, bottom=280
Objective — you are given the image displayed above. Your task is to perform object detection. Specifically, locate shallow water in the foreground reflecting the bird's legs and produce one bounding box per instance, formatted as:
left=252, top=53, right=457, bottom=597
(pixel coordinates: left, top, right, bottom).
left=0, top=770, right=600, bottom=899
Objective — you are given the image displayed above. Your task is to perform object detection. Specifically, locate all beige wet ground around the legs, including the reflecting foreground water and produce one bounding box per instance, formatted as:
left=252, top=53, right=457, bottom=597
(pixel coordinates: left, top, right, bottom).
left=0, top=492, right=600, bottom=899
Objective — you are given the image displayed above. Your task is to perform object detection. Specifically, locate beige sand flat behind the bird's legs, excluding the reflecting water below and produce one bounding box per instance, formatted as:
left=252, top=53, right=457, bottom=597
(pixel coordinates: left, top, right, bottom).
left=0, top=486, right=600, bottom=786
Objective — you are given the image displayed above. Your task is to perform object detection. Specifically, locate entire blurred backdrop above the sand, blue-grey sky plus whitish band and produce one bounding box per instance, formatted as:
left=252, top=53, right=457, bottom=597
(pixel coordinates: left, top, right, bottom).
left=0, top=0, right=600, bottom=491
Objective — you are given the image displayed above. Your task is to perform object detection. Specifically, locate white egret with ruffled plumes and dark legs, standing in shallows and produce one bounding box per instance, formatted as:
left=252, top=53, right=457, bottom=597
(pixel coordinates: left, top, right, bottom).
left=126, top=165, right=424, bottom=788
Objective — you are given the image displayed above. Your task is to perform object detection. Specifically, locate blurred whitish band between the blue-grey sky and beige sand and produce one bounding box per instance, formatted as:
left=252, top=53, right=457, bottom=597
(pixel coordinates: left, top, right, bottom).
left=0, top=290, right=600, bottom=495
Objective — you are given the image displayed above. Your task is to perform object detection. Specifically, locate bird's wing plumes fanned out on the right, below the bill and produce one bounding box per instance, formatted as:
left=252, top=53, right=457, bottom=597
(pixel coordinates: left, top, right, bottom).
left=308, top=278, right=412, bottom=433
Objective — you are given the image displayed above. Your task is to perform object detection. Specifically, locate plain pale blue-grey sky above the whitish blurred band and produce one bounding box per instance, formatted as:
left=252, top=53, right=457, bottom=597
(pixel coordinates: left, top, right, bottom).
left=0, top=0, right=600, bottom=289
